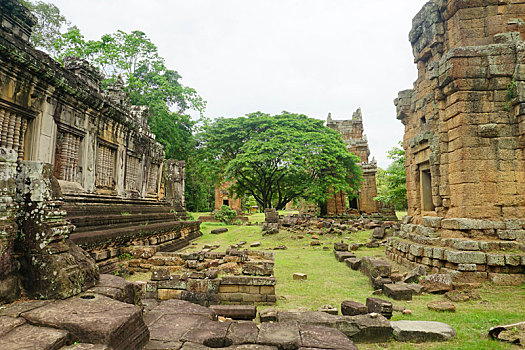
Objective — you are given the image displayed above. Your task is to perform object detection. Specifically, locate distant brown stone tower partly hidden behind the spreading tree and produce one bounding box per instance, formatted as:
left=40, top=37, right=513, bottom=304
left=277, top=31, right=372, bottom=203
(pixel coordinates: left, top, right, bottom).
left=326, top=109, right=378, bottom=215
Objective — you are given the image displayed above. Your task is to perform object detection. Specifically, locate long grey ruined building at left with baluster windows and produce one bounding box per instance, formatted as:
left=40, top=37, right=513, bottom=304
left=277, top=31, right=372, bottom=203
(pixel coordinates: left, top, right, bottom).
left=0, top=0, right=199, bottom=303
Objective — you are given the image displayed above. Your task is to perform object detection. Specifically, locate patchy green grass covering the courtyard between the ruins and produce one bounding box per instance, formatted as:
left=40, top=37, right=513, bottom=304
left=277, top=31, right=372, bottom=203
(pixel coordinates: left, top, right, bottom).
left=182, top=214, right=525, bottom=350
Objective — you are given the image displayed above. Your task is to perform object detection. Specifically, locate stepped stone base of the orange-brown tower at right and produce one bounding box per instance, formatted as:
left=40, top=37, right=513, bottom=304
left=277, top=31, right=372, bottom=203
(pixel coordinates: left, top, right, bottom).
left=387, top=217, right=525, bottom=285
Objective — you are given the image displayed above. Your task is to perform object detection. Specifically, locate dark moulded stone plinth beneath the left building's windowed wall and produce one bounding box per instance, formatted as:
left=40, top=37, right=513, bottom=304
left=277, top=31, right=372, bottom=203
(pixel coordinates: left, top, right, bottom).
left=63, top=195, right=201, bottom=273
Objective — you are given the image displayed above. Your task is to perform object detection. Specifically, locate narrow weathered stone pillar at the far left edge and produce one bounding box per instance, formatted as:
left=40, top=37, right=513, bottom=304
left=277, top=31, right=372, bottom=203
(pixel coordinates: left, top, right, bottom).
left=0, top=148, right=20, bottom=304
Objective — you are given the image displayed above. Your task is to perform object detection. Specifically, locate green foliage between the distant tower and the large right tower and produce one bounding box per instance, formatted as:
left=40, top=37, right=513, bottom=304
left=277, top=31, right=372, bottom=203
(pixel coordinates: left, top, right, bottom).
left=376, top=143, right=407, bottom=210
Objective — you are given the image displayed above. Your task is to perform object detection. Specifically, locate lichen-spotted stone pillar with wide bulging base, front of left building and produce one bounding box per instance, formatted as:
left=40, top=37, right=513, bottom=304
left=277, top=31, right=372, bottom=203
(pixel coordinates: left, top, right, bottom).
left=15, top=161, right=98, bottom=299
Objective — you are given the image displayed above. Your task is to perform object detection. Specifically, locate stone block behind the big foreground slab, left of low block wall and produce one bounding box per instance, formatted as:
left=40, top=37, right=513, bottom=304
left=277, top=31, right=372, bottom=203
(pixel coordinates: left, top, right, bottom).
left=87, top=272, right=141, bottom=305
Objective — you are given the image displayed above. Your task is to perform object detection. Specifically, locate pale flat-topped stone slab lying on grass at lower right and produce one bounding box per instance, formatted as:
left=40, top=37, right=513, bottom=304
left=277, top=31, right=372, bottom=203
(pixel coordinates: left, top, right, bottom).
left=391, top=320, right=456, bottom=343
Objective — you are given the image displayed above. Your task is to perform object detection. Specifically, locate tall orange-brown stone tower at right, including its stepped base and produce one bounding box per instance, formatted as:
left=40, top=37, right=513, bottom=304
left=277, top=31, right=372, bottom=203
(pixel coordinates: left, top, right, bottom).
left=387, top=0, right=525, bottom=284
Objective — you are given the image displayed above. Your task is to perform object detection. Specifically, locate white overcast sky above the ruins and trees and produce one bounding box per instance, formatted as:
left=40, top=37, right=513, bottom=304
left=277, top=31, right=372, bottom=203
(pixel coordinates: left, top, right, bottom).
left=48, top=0, right=426, bottom=167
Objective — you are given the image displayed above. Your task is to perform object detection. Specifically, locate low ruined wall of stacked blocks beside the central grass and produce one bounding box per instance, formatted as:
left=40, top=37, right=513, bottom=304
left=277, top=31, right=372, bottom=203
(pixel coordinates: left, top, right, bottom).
left=139, top=248, right=276, bottom=305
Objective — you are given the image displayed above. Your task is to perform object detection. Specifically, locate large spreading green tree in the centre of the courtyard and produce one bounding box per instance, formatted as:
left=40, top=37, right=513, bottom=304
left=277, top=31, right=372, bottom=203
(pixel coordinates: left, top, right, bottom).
left=200, top=112, right=362, bottom=209
